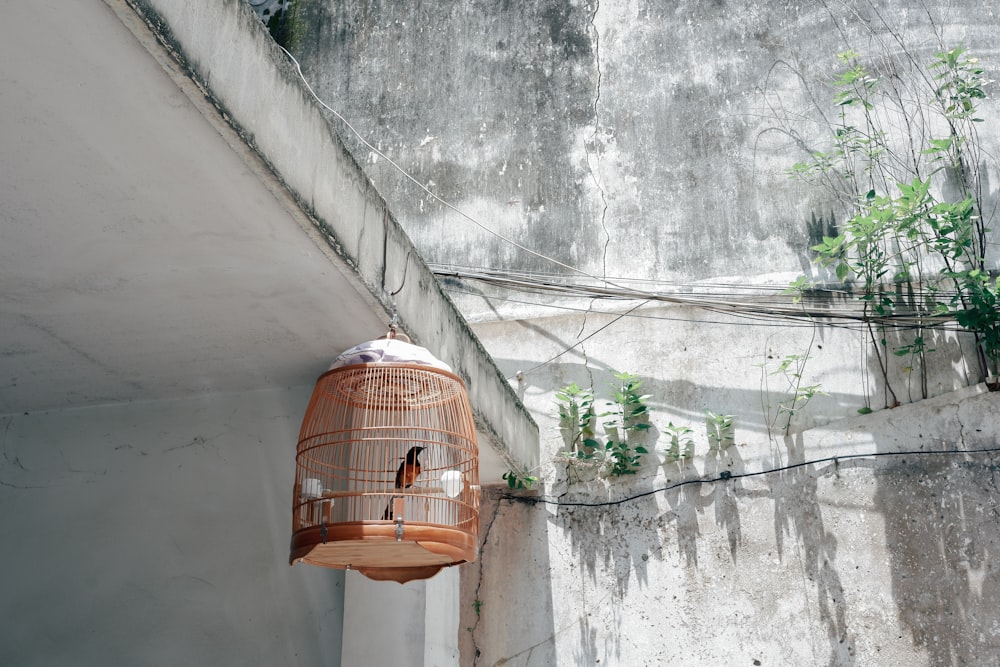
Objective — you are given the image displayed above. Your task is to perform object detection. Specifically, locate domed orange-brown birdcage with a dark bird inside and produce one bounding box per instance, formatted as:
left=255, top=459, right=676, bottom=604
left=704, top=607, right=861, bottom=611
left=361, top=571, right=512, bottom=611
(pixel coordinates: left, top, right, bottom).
left=290, top=334, right=479, bottom=582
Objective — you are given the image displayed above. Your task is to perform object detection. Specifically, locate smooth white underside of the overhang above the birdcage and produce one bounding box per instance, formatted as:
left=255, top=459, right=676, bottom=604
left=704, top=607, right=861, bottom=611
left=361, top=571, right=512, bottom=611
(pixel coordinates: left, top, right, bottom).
left=0, top=0, right=385, bottom=414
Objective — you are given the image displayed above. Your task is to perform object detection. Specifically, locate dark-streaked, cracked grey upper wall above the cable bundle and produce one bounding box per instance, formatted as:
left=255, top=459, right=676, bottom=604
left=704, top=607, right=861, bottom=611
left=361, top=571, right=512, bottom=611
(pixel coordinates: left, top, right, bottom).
left=287, top=0, right=1000, bottom=281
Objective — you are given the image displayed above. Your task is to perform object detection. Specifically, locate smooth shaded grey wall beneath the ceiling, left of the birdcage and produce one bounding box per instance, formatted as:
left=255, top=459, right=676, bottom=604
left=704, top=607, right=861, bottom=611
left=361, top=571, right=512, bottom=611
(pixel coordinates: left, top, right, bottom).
left=0, top=387, right=344, bottom=667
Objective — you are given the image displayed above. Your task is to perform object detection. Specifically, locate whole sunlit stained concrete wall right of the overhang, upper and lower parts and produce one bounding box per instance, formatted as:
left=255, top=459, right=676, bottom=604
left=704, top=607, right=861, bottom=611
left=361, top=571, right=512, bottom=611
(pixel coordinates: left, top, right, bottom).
left=264, top=0, right=1000, bottom=666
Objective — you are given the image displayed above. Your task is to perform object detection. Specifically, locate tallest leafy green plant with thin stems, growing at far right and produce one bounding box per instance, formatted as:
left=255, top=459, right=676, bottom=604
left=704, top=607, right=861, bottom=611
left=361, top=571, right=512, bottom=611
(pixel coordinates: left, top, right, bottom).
left=789, top=45, right=1000, bottom=405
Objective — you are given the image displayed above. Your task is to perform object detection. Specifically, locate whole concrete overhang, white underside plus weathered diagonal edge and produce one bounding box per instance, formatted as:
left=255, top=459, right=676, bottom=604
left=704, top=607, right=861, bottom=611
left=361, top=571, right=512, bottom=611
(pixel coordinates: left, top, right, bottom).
left=0, top=0, right=538, bottom=483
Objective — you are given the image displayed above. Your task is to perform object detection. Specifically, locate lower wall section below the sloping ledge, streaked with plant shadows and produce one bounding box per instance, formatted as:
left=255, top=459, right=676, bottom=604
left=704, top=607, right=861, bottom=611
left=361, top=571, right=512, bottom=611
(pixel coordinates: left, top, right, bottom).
left=461, top=386, right=1000, bottom=667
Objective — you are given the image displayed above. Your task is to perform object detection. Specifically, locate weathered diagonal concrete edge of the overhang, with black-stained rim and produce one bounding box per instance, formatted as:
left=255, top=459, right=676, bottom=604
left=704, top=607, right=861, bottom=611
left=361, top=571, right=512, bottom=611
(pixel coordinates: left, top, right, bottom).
left=113, top=0, right=538, bottom=483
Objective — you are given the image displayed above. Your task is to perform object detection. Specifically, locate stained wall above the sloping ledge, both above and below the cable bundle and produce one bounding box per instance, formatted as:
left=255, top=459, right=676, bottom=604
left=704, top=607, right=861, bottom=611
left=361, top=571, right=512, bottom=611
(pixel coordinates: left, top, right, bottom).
left=274, top=0, right=1000, bottom=444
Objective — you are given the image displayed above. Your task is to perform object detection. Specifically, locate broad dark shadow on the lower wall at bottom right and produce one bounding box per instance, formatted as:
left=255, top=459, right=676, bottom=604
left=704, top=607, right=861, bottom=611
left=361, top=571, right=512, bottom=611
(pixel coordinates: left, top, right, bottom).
left=875, top=456, right=1000, bottom=665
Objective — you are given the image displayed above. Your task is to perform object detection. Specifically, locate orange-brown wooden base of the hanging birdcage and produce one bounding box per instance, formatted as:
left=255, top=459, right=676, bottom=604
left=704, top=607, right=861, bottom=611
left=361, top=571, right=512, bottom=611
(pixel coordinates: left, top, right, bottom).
left=289, top=522, right=476, bottom=583
